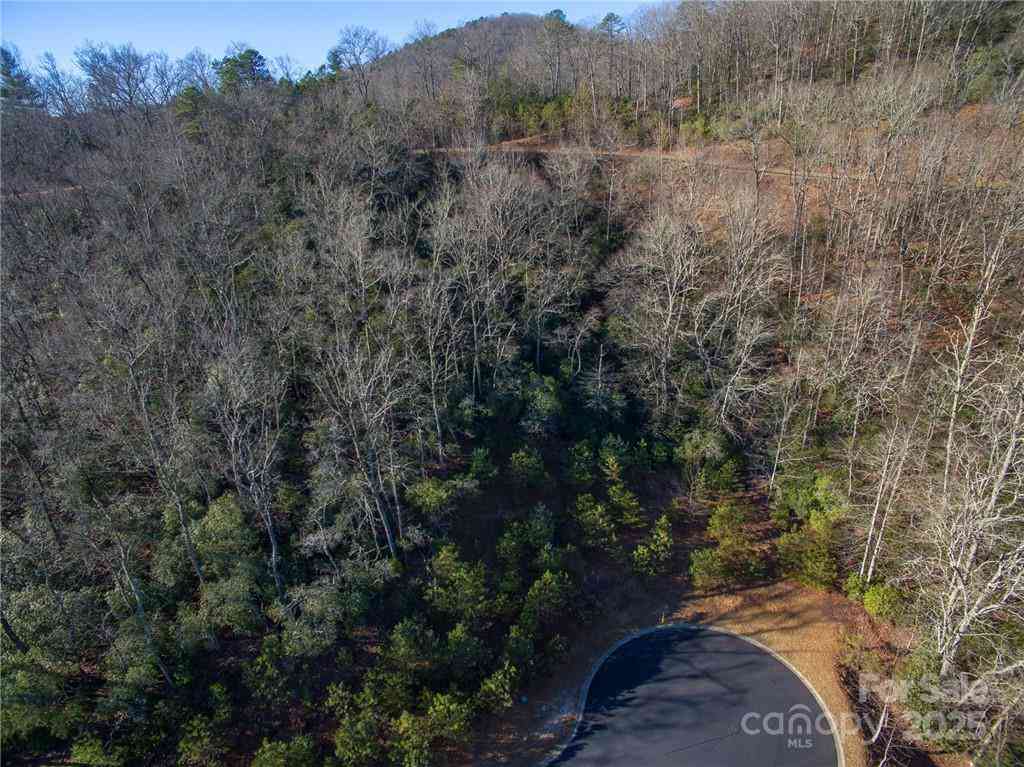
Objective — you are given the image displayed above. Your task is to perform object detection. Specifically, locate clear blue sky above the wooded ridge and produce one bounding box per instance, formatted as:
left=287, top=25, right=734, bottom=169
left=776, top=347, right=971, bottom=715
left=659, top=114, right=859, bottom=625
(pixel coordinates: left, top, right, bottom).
left=0, top=0, right=646, bottom=70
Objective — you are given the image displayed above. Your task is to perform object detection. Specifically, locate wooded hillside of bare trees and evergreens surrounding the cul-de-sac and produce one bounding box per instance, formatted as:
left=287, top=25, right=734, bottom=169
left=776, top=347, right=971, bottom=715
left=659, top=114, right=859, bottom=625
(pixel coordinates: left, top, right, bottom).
left=0, top=2, right=1024, bottom=767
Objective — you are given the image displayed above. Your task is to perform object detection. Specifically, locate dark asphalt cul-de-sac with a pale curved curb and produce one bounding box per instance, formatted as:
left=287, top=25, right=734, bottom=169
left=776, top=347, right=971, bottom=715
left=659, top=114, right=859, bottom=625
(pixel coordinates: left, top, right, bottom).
left=553, top=627, right=839, bottom=767
